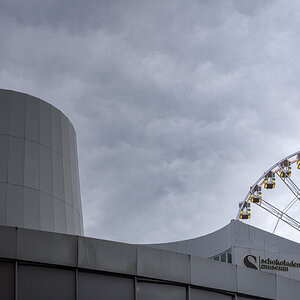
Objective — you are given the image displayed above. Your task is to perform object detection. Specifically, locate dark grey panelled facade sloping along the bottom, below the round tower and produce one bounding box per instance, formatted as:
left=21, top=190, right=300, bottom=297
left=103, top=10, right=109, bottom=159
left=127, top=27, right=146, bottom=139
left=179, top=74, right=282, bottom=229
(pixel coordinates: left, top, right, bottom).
left=0, top=226, right=300, bottom=300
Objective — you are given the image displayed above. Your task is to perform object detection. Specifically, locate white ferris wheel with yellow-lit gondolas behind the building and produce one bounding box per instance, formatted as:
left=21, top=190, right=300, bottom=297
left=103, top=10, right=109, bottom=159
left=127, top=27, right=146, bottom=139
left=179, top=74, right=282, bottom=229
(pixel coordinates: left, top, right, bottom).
left=236, top=151, right=300, bottom=233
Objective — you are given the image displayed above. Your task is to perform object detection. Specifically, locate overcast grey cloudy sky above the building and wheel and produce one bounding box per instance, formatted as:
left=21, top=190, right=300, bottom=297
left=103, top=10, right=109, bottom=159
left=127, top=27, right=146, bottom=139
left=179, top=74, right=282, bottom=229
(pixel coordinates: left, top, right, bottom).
left=0, top=0, right=300, bottom=243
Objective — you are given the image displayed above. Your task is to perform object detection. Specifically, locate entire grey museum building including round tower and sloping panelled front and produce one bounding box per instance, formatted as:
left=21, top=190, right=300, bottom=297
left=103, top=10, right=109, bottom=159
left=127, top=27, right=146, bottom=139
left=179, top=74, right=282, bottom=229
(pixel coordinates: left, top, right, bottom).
left=0, top=90, right=300, bottom=300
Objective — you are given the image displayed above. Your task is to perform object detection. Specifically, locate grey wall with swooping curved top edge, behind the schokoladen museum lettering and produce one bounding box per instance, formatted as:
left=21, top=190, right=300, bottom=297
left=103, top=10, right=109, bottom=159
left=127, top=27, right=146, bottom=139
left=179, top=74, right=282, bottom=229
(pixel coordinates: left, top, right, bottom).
left=149, top=220, right=300, bottom=281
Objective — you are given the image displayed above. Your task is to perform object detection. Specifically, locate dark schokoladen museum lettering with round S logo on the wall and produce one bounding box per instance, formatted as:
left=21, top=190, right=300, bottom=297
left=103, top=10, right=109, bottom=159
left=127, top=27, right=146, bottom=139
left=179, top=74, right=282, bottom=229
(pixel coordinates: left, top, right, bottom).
left=244, top=255, right=300, bottom=272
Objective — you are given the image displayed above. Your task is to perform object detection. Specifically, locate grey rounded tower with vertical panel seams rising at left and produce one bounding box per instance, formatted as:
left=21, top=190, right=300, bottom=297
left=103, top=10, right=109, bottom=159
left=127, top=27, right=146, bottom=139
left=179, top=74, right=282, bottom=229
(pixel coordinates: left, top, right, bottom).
left=0, top=89, right=83, bottom=235
